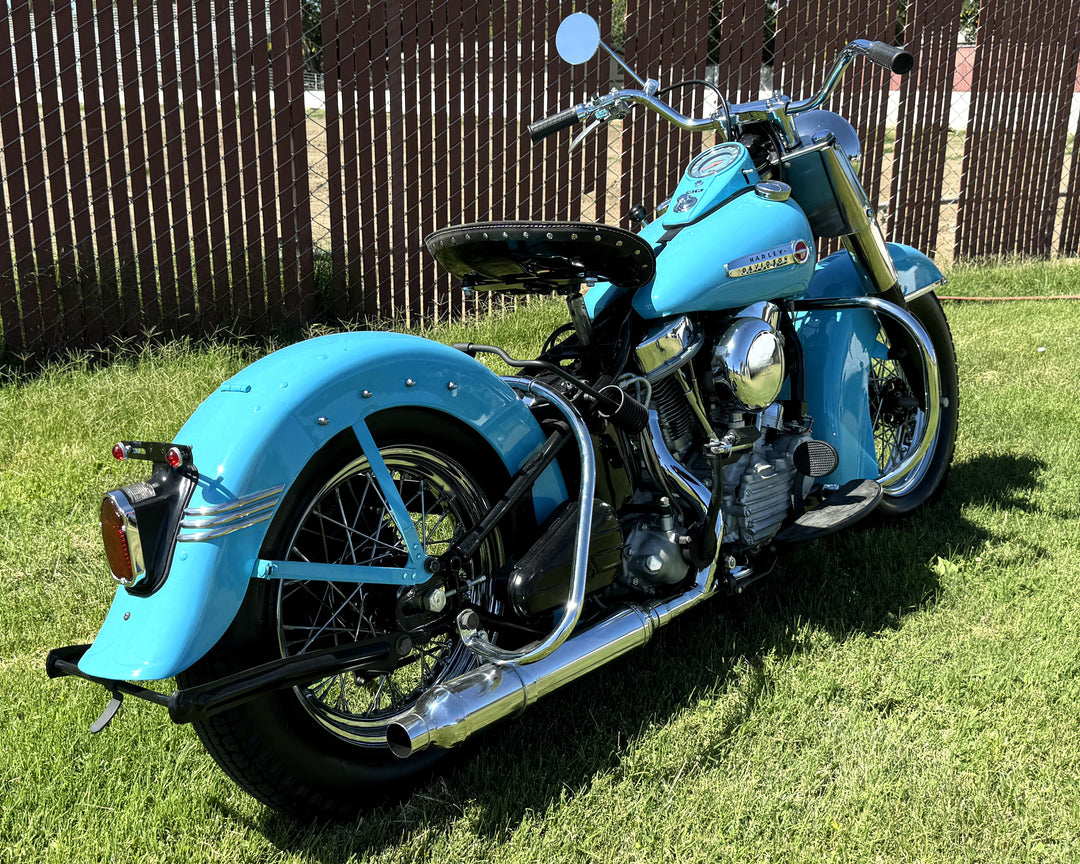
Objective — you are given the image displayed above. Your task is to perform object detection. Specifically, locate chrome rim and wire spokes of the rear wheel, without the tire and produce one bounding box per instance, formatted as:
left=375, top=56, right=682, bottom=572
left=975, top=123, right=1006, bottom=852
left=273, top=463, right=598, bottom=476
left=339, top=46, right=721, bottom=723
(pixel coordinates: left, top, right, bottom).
left=274, top=445, right=500, bottom=751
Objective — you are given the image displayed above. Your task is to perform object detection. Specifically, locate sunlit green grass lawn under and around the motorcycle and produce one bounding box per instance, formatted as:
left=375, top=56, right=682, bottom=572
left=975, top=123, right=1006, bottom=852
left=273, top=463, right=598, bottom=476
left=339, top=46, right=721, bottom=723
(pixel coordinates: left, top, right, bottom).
left=0, top=264, right=1080, bottom=864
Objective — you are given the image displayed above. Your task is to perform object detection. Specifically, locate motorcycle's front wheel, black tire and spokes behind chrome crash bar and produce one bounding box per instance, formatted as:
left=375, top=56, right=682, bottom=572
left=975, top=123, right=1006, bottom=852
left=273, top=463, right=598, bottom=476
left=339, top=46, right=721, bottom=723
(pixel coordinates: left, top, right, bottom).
left=869, top=294, right=958, bottom=515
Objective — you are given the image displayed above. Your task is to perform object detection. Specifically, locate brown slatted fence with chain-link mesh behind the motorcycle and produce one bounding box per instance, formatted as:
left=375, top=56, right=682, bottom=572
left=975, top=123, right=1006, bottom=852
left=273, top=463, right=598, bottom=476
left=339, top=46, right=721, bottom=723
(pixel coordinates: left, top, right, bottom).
left=0, top=0, right=1080, bottom=355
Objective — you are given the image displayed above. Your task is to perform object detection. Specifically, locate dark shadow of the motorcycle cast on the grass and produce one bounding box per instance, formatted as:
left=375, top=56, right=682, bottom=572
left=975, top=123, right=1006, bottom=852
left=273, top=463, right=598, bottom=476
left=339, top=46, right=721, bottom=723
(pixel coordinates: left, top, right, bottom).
left=230, top=455, right=1045, bottom=861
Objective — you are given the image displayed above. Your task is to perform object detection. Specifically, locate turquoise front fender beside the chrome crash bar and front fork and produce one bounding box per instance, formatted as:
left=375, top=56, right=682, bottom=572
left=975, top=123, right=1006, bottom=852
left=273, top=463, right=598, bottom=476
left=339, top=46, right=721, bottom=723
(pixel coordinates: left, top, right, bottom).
left=795, top=243, right=945, bottom=485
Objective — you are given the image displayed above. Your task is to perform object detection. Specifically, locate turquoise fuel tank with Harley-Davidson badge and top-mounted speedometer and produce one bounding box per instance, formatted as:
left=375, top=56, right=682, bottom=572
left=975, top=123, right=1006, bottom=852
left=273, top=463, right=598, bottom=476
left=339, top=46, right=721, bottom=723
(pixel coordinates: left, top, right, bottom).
left=585, top=143, right=816, bottom=319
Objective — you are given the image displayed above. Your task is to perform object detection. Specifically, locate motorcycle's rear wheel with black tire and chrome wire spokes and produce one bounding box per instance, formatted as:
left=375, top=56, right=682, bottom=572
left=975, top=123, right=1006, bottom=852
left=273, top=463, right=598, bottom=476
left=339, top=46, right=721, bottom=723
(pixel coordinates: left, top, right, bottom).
left=179, top=413, right=504, bottom=819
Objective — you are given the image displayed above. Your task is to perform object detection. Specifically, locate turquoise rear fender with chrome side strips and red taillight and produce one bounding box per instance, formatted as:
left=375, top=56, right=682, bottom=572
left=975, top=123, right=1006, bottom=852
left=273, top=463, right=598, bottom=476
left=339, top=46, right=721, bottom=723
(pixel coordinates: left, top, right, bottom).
left=79, top=333, right=566, bottom=680
